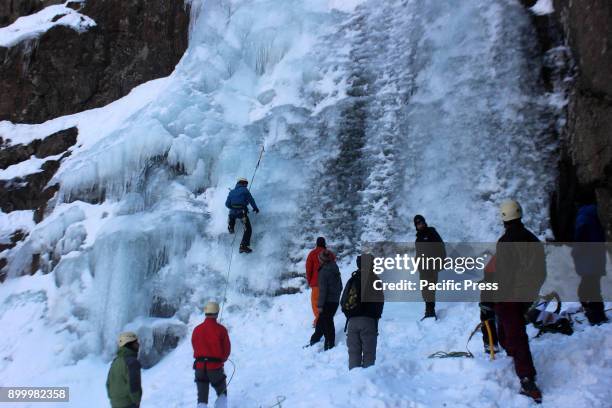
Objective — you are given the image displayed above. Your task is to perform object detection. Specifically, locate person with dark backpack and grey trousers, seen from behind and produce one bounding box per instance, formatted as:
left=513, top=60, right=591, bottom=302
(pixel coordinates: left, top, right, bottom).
left=341, top=255, right=384, bottom=370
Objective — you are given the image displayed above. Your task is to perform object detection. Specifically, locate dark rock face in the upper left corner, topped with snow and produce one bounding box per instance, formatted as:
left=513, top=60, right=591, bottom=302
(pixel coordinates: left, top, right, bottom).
left=0, top=0, right=189, bottom=123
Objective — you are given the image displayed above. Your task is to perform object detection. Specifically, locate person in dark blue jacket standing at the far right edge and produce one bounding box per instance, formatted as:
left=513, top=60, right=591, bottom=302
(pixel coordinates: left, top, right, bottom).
left=572, top=190, right=608, bottom=325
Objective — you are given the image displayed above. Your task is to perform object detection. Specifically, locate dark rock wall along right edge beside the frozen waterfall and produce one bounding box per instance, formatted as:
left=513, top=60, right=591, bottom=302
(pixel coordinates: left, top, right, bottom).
left=552, top=0, right=612, bottom=241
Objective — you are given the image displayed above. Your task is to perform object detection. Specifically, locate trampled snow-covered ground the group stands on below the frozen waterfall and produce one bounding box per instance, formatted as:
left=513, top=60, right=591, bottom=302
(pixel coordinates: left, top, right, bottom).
left=0, top=268, right=612, bottom=408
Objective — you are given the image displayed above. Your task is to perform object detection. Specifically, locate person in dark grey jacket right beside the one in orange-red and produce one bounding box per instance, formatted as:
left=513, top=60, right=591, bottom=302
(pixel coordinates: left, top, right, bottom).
left=310, top=249, right=342, bottom=350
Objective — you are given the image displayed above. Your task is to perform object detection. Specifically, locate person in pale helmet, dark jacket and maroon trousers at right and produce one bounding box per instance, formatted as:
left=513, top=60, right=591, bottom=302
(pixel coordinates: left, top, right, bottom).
left=493, top=200, right=546, bottom=403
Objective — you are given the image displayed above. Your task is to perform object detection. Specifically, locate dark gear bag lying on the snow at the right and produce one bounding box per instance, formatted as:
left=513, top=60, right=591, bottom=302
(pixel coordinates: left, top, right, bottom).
left=525, top=292, right=574, bottom=337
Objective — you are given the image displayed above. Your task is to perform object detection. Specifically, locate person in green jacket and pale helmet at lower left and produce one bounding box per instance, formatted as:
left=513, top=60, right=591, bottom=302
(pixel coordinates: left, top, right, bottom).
left=106, top=332, right=142, bottom=408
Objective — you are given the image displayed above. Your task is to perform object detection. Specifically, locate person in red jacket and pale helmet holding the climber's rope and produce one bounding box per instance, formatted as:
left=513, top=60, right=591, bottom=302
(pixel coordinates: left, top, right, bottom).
left=191, top=302, right=231, bottom=408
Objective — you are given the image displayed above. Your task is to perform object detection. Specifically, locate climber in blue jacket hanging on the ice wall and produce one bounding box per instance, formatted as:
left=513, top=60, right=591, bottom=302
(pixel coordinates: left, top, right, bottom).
left=225, top=178, right=259, bottom=254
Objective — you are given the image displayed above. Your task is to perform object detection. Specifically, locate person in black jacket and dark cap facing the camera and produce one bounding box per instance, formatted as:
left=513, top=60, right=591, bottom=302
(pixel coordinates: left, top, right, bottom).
left=414, top=214, right=446, bottom=320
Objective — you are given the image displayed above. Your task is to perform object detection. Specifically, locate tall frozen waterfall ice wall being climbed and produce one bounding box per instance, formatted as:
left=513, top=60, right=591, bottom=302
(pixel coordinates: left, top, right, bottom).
left=1, top=0, right=556, bottom=360
